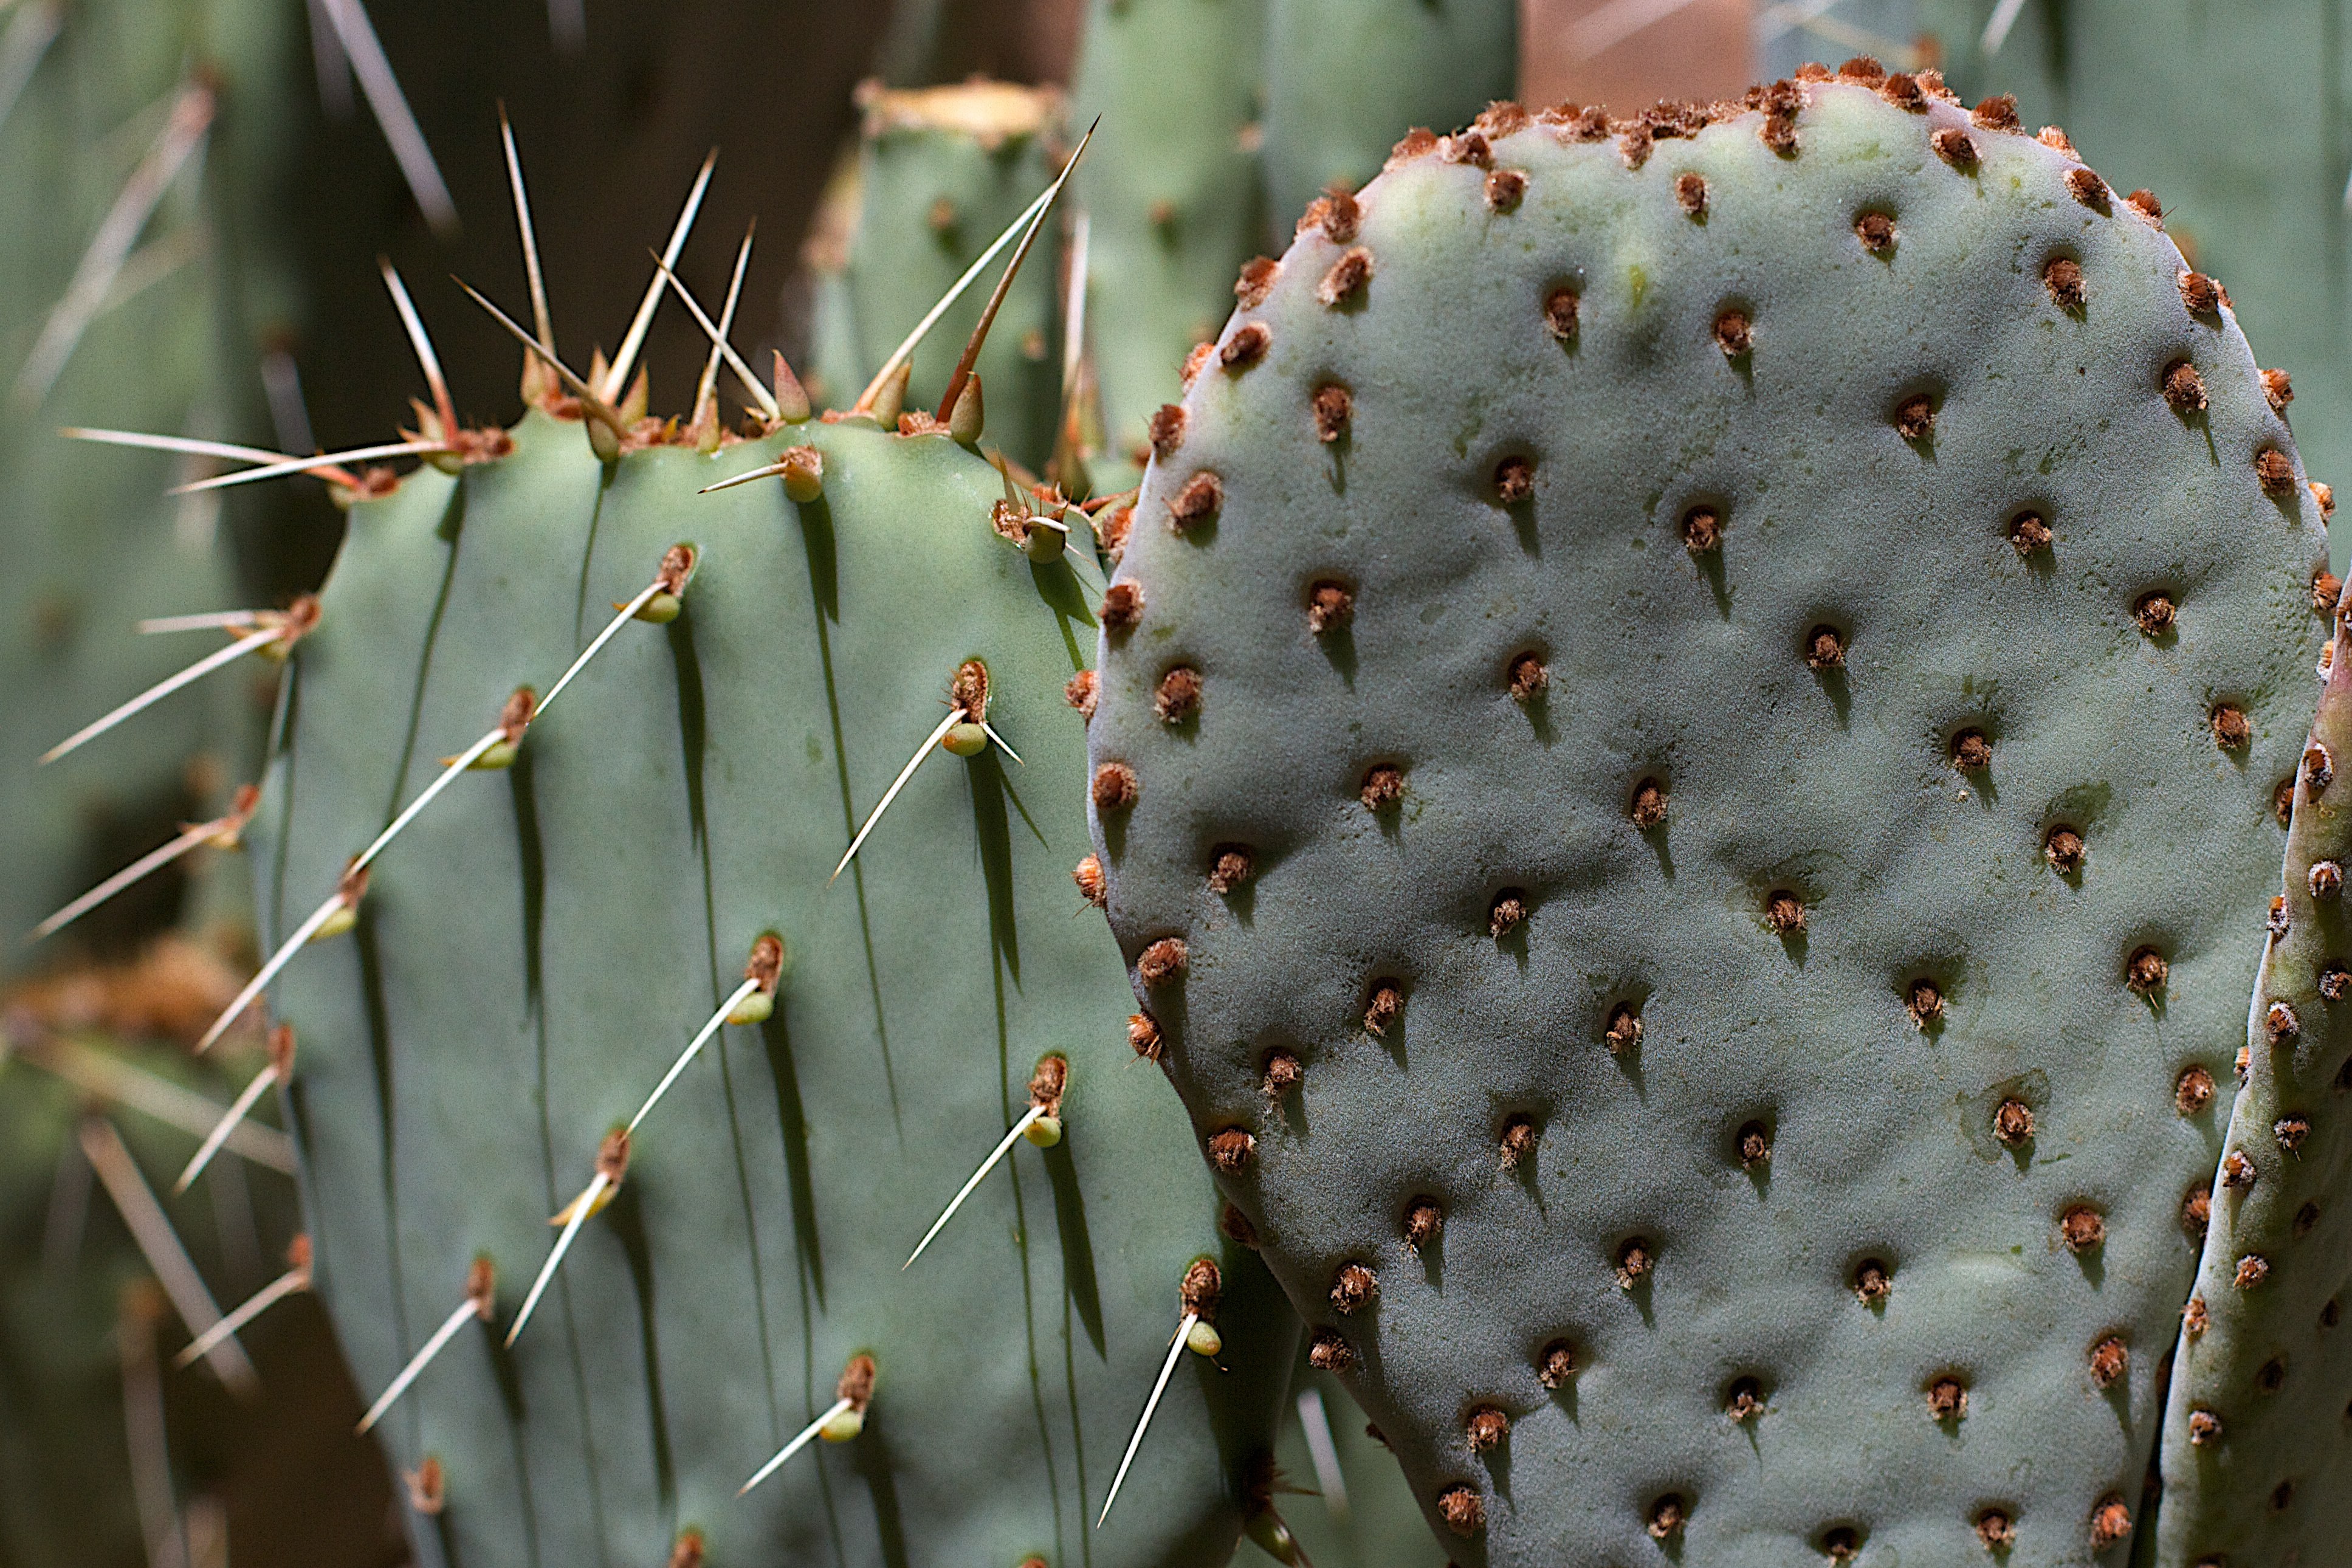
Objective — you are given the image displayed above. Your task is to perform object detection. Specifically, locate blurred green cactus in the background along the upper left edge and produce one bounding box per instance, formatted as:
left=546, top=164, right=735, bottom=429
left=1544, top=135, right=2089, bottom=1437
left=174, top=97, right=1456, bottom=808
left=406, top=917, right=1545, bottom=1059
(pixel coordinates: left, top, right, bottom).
left=0, top=0, right=289, bottom=973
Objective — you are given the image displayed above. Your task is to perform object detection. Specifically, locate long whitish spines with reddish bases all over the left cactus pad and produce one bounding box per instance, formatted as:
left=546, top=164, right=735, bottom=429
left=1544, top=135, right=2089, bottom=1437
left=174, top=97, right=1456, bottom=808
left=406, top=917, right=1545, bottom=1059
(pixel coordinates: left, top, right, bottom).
left=32, top=132, right=1287, bottom=1566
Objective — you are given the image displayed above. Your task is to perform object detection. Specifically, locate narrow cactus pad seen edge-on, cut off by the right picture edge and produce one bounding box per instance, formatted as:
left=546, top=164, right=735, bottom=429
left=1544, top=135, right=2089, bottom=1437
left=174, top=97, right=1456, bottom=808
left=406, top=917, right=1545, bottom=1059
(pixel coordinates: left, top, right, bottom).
left=2154, top=633, right=2352, bottom=1568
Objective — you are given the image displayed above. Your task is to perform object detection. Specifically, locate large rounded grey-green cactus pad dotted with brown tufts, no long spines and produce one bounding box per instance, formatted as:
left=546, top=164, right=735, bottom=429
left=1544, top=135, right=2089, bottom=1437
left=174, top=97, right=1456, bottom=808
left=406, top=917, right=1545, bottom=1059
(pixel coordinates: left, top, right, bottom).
left=1092, top=76, right=2326, bottom=1563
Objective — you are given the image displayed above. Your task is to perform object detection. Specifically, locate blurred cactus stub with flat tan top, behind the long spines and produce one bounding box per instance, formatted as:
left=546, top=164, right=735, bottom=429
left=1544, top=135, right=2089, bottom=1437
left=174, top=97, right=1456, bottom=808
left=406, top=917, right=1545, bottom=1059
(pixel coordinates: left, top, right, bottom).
left=816, top=82, right=1061, bottom=466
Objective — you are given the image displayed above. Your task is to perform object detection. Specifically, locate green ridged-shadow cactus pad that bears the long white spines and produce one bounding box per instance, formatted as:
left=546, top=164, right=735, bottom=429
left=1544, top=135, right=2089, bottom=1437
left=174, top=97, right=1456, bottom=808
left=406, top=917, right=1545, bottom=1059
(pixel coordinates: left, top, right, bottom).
left=254, top=399, right=1296, bottom=1568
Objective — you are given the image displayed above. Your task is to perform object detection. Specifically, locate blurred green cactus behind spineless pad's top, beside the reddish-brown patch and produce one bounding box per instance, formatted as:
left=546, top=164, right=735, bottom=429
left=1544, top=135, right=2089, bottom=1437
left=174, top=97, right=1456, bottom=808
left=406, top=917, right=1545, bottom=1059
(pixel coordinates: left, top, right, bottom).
left=1265, top=0, right=1519, bottom=244
